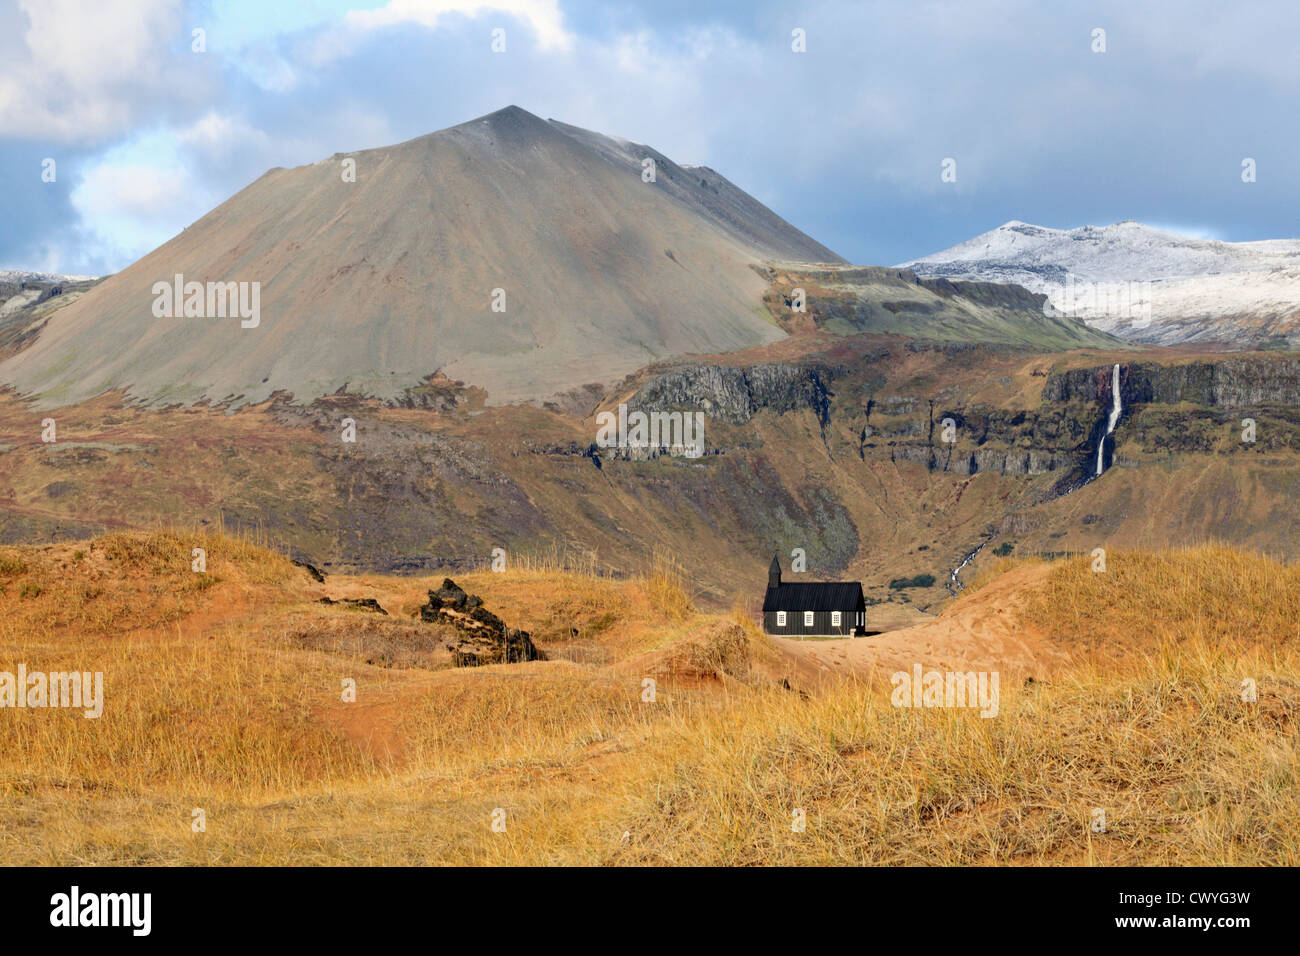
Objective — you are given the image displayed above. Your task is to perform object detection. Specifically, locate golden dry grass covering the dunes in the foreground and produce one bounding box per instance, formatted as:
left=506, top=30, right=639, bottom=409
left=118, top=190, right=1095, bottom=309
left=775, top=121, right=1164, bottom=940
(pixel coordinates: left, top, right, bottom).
left=0, top=532, right=1300, bottom=865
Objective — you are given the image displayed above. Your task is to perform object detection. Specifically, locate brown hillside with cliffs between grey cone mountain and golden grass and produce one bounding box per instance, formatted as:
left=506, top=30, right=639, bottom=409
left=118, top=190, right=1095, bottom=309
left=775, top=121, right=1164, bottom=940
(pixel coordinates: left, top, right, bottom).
left=0, top=332, right=1300, bottom=613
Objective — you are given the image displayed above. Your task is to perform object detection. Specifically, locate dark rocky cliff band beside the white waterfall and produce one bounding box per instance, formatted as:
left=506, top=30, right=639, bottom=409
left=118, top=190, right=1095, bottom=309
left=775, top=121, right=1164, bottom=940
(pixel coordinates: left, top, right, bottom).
left=631, top=345, right=1300, bottom=494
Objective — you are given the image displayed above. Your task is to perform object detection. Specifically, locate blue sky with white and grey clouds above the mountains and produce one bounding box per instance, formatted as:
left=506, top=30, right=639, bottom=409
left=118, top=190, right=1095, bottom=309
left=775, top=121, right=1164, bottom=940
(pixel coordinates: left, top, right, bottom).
left=0, top=0, right=1300, bottom=274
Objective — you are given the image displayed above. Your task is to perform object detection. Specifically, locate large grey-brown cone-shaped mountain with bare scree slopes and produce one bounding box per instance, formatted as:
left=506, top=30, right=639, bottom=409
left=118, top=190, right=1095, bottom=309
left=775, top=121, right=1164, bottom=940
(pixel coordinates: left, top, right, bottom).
left=0, top=107, right=844, bottom=407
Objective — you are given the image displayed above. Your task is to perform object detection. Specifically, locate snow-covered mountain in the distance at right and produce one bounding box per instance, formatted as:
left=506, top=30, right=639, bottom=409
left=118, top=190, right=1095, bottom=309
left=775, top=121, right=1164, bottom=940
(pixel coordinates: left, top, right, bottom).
left=900, top=220, right=1300, bottom=347
